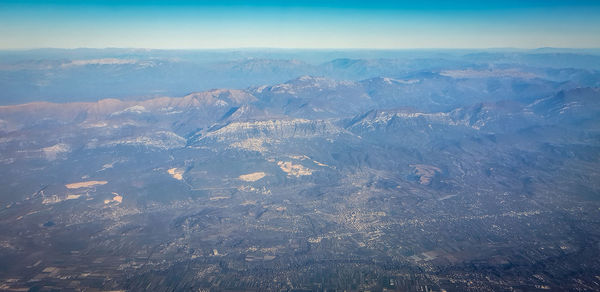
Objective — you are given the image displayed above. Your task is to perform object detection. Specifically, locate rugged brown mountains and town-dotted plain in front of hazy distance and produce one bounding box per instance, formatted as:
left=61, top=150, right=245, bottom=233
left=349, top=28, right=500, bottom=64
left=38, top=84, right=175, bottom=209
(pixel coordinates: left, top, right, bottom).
left=0, top=51, right=600, bottom=291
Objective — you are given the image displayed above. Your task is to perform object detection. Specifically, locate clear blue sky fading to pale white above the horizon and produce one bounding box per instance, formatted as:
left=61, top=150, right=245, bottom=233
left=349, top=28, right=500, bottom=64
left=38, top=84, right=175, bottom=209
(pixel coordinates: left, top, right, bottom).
left=0, top=0, right=600, bottom=49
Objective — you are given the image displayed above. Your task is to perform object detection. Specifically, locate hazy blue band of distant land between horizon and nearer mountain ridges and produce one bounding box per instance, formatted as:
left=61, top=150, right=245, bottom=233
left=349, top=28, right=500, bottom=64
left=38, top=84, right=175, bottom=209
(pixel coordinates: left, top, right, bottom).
left=0, top=49, right=600, bottom=106
